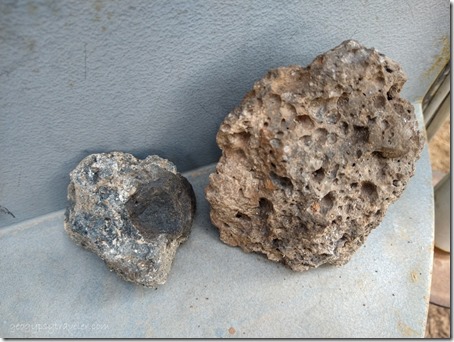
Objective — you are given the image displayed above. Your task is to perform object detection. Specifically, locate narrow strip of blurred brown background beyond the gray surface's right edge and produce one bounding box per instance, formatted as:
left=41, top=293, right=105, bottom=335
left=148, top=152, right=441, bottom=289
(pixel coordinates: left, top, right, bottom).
left=423, top=63, right=451, bottom=338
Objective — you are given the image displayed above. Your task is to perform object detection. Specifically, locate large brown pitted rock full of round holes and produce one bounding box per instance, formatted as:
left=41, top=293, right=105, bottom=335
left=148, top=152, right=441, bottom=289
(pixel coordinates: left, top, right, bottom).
left=206, top=40, right=424, bottom=271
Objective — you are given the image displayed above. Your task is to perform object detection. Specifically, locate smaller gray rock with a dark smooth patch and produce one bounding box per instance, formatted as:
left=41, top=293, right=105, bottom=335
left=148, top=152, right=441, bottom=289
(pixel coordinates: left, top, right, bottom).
left=65, top=152, right=196, bottom=287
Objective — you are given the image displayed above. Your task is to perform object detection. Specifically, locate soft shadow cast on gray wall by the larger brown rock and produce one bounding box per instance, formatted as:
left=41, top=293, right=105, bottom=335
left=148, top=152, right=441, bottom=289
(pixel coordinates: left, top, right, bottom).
left=159, top=21, right=322, bottom=172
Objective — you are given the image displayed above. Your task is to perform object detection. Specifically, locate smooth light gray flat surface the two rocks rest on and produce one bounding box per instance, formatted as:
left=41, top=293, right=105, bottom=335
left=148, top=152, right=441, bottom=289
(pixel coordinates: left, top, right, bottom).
left=0, top=137, right=433, bottom=337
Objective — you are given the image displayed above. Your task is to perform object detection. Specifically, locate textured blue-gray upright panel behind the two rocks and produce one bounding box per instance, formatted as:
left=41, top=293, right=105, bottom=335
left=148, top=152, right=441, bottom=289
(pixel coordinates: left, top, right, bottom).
left=0, top=0, right=449, bottom=226
